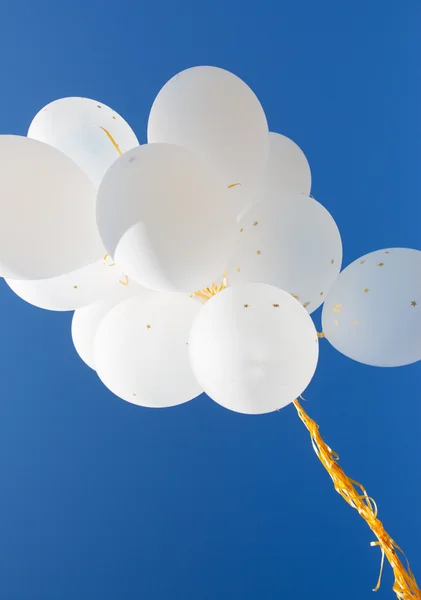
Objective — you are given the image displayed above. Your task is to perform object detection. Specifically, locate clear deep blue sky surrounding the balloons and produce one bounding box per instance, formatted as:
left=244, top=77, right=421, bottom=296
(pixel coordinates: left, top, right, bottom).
left=0, top=0, right=421, bottom=600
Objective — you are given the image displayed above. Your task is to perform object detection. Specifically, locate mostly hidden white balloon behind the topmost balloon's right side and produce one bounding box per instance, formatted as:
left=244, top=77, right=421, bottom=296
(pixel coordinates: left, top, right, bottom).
left=264, top=132, right=311, bottom=198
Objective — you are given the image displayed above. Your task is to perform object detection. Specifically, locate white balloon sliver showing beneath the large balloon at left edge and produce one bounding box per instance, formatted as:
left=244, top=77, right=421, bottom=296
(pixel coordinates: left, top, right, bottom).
left=6, top=260, right=125, bottom=311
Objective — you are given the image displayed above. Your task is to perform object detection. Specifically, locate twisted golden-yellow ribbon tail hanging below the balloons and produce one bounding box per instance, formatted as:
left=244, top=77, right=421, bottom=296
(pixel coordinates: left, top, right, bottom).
left=294, top=400, right=421, bottom=600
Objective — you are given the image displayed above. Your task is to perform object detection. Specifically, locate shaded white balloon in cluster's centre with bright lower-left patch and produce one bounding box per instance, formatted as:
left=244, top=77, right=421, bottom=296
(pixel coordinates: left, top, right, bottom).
left=97, top=144, right=236, bottom=293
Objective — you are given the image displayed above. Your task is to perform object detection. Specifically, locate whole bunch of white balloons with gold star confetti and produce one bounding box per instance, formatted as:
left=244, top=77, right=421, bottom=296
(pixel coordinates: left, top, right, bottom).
left=0, top=67, right=421, bottom=414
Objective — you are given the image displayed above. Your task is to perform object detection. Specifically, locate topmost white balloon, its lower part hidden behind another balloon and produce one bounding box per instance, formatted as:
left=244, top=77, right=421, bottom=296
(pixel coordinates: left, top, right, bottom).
left=148, top=66, right=269, bottom=195
